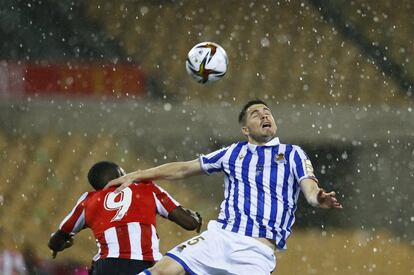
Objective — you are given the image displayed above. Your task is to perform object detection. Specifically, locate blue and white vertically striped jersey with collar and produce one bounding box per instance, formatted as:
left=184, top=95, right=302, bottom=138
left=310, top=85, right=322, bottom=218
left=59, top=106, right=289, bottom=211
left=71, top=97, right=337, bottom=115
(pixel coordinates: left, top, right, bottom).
left=200, top=138, right=315, bottom=249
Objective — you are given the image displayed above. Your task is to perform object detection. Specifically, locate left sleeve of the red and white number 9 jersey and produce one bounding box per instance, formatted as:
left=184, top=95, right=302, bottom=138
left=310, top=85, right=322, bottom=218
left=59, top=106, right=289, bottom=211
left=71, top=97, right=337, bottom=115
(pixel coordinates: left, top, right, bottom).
left=59, top=192, right=89, bottom=234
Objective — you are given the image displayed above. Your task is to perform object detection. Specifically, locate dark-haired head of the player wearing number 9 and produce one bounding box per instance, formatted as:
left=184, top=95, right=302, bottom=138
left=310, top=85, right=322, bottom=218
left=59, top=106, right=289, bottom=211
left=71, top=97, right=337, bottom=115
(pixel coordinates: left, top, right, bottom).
left=88, top=161, right=125, bottom=190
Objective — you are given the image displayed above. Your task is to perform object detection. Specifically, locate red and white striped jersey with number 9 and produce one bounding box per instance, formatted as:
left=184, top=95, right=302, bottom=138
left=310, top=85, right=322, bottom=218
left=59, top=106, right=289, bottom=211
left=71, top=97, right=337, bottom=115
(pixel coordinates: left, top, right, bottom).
left=59, top=182, right=179, bottom=261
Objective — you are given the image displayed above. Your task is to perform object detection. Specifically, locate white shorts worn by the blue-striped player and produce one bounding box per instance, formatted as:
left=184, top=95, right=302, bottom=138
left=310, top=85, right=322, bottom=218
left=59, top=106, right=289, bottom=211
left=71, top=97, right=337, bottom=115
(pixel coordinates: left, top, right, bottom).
left=166, top=221, right=276, bottom=275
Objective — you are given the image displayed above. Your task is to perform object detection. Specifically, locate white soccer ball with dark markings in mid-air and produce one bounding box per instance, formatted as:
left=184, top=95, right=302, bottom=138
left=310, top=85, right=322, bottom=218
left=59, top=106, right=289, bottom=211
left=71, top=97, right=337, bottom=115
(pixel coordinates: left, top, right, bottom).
left=185, top=42, right=228, bottom=84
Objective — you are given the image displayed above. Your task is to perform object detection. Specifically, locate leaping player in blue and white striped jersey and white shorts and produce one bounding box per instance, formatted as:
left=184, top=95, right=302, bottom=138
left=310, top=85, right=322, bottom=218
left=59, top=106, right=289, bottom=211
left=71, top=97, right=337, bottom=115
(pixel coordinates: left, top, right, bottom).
left=109, top=100, right=342, bottom=274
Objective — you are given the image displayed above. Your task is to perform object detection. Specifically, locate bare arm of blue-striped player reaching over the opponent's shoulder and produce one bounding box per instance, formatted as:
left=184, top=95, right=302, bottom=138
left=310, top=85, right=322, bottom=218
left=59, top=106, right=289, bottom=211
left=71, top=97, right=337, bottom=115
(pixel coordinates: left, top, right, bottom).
left=105, top=159, right=203, bottom=191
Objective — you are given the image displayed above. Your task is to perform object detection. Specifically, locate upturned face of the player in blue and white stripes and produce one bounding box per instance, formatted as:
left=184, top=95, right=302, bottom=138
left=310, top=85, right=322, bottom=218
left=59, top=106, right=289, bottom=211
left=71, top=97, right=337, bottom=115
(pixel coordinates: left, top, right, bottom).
left=242, top=104, right=277, bottom=145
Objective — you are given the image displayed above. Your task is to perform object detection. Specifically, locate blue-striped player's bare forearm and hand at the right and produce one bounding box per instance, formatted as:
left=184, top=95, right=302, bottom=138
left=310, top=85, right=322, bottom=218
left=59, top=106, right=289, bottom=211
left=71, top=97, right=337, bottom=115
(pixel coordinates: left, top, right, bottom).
left=300, top=179, right=342, bottom=209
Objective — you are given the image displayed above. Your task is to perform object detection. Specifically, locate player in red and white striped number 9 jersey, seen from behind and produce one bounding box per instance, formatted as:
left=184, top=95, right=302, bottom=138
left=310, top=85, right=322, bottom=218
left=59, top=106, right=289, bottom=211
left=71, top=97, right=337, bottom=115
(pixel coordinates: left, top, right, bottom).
left=49, top=161, right=201, bottom=275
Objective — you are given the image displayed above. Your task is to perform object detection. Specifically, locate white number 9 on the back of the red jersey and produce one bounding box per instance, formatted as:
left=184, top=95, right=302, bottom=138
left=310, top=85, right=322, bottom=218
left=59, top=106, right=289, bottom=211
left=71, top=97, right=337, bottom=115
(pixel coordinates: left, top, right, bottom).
left=104, top=187, right=132, bottom=222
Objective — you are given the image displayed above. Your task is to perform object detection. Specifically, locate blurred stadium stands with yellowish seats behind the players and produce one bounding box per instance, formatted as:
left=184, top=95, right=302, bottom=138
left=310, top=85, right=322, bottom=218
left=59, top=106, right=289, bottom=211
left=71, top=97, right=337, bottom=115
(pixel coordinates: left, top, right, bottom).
left=0, top=0, right=414, bottom=274
